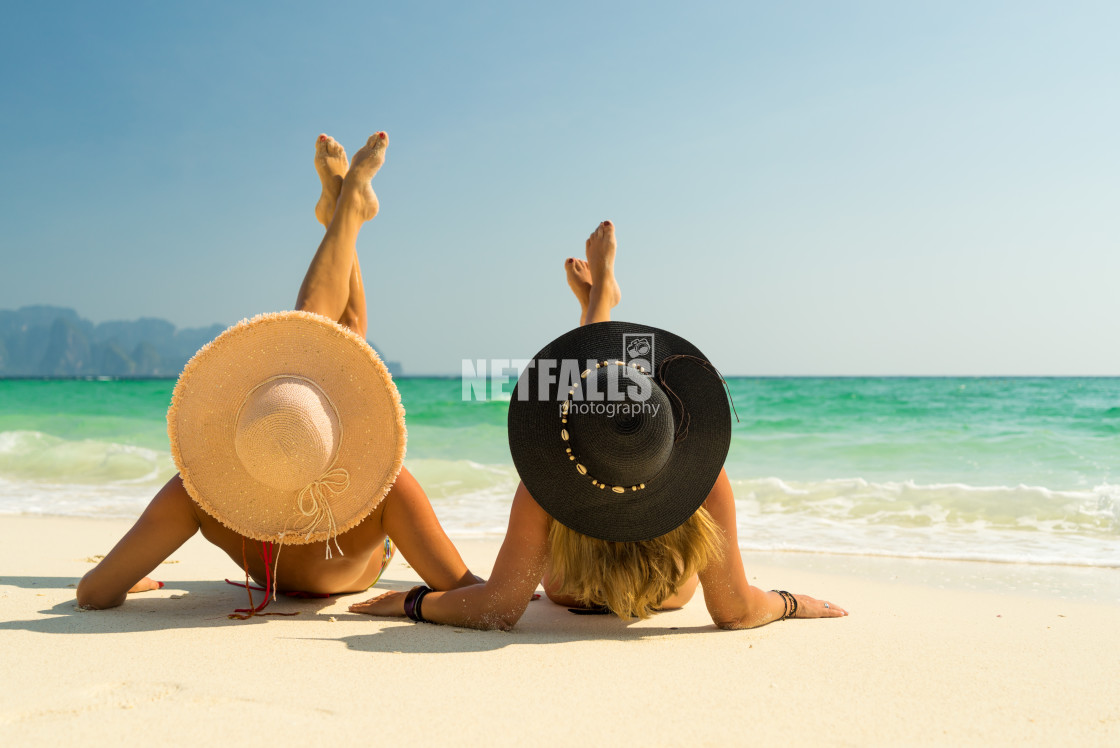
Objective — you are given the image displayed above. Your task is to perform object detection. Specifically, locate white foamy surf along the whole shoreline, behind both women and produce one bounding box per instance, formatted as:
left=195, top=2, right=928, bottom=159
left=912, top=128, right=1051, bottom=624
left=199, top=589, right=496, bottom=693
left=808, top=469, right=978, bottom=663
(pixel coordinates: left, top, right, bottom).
left=0, top=429, right=1120, bottom=567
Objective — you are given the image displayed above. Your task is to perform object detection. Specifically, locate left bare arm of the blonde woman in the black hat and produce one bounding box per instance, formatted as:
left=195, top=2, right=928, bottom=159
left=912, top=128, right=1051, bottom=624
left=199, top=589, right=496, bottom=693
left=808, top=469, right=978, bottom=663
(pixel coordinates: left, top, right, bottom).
left=351, top=484, right=549, bottom=629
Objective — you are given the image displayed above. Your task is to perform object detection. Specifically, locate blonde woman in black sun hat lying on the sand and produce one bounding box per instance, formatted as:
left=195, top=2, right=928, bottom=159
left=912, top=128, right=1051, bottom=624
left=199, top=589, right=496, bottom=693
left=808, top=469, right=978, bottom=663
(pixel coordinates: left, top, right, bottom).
left=351, top=221, right=848, bottom=629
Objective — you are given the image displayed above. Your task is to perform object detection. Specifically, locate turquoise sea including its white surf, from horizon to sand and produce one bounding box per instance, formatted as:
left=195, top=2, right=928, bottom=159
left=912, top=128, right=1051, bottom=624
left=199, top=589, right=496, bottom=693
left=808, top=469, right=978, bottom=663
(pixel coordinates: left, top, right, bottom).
left=0, top=377, right=1120, bottom=567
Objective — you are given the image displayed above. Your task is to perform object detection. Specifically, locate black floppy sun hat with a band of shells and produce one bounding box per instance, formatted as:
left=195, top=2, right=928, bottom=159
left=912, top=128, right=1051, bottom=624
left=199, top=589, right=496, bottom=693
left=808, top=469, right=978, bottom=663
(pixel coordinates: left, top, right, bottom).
left=508, top=322, right=731, bottom=542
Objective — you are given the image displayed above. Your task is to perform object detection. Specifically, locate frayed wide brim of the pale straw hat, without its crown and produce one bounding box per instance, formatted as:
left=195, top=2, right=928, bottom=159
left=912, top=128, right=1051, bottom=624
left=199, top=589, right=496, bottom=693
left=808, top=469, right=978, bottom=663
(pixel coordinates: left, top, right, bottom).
left=167, top=311, right=407, bottom=544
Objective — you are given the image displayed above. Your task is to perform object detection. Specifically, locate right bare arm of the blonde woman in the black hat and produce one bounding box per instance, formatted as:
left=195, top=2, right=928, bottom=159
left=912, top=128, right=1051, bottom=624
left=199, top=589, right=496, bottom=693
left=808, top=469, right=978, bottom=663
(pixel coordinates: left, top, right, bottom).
left=700, top=470, right=848, bottom=628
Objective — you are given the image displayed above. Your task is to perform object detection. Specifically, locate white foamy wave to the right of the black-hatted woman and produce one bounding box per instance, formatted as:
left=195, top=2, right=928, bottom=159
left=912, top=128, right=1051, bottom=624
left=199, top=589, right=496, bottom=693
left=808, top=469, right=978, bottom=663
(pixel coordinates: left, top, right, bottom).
left=732, top=478, right=1120, bottom=568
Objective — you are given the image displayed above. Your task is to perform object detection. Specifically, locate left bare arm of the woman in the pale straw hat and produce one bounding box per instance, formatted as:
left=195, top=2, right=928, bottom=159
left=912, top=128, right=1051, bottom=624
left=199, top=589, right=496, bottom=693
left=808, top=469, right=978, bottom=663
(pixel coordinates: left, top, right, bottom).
left=77, top=475, right=198, bottom=609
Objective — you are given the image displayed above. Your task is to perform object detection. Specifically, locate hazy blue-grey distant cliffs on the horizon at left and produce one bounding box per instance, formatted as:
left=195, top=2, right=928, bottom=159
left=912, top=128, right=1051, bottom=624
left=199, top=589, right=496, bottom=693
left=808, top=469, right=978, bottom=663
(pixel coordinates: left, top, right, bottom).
left=0, top=307, right=401, bottom=377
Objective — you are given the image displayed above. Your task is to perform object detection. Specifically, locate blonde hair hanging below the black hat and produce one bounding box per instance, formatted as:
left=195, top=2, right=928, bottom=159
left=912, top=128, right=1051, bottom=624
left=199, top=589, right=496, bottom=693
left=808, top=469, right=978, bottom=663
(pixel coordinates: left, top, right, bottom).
left=549, top=506, right=724, bottom=618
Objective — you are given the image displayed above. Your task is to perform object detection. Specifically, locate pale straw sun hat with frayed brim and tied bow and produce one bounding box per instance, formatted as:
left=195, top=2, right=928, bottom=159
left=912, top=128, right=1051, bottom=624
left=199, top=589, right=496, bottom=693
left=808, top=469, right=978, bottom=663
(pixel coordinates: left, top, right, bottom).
left=167, top=311, right=405, bottom=544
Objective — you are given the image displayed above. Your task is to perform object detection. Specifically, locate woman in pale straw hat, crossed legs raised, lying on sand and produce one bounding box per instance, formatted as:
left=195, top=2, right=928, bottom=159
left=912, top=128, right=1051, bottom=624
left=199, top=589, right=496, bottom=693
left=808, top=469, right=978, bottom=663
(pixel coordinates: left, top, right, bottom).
left=77, top=132, right=478, bottom=617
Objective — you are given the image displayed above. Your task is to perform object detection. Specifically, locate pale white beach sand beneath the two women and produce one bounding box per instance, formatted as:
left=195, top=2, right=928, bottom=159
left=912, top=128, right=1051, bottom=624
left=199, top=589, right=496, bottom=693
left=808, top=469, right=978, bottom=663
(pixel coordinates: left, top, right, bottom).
left=0, top=516, right=1120, bottom=746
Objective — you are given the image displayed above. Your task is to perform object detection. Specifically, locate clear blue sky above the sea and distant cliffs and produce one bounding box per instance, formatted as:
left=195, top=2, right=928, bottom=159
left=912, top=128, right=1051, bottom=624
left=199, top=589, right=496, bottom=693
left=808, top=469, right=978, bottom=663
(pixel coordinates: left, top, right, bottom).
left=0, top=1, right=1120, bottom=374
